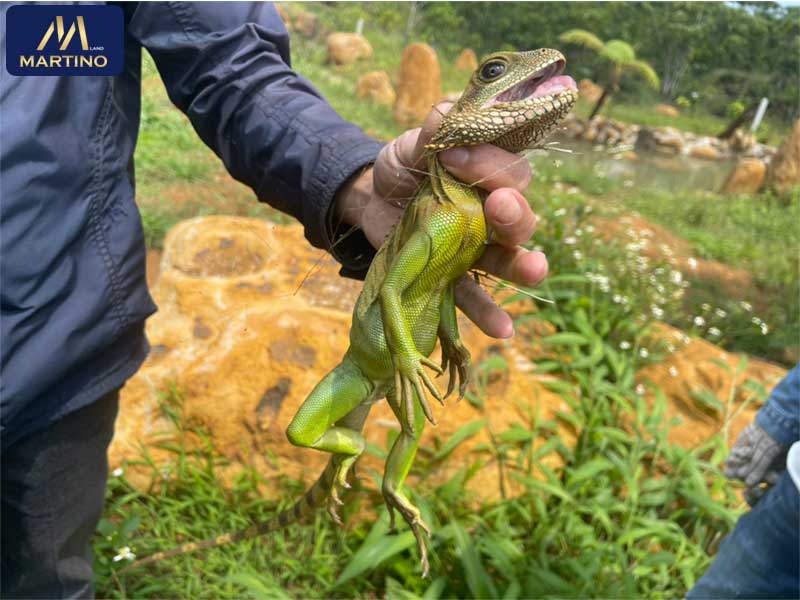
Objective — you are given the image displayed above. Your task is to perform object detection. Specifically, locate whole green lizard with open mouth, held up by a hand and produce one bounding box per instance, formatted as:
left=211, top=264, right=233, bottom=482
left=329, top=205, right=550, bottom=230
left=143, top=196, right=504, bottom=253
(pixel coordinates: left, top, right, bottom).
left=125, top=49, right=577, bottom=575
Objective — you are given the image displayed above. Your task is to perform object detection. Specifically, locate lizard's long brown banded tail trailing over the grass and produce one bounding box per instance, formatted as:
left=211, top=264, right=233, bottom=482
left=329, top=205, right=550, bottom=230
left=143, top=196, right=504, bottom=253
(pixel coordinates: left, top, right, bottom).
left=118, top=460, right=336, bottom=575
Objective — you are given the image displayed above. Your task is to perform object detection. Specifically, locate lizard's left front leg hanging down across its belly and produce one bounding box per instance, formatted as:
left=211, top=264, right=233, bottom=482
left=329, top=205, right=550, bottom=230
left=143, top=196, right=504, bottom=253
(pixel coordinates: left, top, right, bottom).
left=380, top=230, right=442, bottom=431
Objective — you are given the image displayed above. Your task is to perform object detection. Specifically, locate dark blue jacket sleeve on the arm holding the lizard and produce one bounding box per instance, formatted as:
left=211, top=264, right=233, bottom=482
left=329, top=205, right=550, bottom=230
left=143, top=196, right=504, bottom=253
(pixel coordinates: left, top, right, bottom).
left=126, top=2, right=381, bottom=276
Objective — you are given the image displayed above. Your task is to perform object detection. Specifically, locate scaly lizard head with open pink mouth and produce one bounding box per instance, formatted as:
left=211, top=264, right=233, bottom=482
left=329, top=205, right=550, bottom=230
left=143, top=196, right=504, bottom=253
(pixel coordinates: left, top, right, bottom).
left=426, top=48, right=578, bottom=152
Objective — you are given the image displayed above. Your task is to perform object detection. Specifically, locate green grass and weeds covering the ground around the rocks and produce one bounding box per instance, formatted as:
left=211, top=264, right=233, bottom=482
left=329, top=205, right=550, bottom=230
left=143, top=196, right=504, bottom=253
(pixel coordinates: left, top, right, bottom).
left=101, top=12, right=800, bottom=599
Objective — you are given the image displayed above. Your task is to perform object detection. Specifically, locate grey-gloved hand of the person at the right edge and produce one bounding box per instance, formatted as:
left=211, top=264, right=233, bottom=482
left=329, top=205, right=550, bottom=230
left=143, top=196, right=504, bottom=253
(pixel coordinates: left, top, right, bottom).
left=725, top=423, right=787, bottom=506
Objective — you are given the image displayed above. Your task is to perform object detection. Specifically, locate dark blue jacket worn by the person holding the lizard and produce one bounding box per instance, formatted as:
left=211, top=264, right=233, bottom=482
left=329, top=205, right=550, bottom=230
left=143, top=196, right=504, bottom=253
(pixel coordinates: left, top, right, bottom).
left=0, top=2, right=380, bottom=448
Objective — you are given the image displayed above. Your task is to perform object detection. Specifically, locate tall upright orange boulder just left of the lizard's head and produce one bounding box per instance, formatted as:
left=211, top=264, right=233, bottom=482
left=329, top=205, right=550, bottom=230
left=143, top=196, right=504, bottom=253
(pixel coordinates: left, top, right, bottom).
left=394, top=43, right=442, bottom=127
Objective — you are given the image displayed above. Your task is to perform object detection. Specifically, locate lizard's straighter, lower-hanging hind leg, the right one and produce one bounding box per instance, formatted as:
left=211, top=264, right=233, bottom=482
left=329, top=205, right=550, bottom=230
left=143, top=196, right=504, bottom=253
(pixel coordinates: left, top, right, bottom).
left=382, top=390, right=431, bottom=577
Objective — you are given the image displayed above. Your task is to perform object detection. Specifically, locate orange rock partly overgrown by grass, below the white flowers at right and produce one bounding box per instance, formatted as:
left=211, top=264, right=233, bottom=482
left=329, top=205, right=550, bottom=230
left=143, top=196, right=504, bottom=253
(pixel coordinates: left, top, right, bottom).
left=636, top=324, right=786, bottom=448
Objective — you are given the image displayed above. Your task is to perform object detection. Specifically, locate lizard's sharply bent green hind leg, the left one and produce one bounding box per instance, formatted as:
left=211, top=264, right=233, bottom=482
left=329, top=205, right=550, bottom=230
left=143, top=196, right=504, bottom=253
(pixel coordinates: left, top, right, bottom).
left=286, top=355, right=374, bottom=525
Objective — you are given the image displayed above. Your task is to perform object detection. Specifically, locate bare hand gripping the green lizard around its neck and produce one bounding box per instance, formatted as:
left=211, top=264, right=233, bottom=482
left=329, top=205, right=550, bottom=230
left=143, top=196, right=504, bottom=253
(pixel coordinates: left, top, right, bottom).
left=337, top=104, right=547, bottom=338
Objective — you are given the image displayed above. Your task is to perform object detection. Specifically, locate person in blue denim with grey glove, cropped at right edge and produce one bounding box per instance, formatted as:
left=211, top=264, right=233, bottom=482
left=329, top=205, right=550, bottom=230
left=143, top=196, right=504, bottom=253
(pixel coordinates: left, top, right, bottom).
left=687, top=365, right=800, bottom=600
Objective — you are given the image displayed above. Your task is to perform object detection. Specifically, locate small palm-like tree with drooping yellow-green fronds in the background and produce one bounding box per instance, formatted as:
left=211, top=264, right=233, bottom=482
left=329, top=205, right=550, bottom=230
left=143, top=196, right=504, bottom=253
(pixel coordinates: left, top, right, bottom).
left=558, top=29, right=659, bottom=120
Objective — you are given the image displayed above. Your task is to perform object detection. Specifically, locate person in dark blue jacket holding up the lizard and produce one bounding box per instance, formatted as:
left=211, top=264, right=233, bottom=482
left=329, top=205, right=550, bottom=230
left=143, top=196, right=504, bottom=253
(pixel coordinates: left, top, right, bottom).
left=0, top=2, right=547, bottom=598
